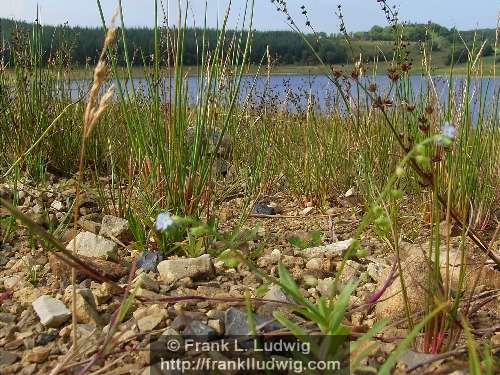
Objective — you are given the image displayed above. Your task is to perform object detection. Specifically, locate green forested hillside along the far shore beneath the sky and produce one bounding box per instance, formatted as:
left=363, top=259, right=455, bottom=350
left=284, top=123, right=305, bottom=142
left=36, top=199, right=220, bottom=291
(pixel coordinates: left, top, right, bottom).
left=0, top=18, right=495, bottom=67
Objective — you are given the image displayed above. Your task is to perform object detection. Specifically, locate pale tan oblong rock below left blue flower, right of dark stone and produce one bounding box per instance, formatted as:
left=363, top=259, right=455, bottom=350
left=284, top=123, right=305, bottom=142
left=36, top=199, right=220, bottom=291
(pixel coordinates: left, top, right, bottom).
left=158, top=254, right=214, bottom=283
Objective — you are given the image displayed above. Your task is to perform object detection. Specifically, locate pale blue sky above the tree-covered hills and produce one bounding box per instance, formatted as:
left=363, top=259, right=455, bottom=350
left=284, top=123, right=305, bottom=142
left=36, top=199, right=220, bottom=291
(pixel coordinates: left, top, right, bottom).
left=0, top=0, right=500, bottom=33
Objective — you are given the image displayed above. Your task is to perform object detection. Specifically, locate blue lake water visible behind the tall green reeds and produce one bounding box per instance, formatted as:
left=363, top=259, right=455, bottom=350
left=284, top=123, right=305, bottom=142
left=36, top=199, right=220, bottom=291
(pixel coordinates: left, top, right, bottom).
left=63, top=74, right=500, bottom=121
